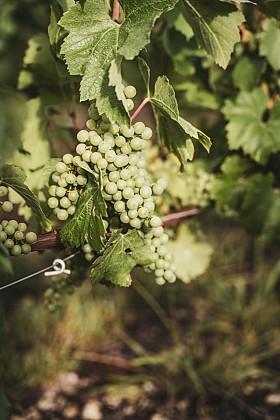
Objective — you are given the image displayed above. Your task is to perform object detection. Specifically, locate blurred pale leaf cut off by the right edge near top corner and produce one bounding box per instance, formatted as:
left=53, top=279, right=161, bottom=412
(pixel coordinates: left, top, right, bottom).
left=260, top=18, right=280, bottom=71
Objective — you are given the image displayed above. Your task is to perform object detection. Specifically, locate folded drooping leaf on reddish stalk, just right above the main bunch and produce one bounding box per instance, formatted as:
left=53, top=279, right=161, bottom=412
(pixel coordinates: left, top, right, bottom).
left=151, top=76, right=211, bottom=169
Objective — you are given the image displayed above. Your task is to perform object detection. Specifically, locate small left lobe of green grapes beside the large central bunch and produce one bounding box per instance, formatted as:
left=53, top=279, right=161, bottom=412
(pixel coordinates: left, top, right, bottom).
left=48, top=153, right=87, bottom=220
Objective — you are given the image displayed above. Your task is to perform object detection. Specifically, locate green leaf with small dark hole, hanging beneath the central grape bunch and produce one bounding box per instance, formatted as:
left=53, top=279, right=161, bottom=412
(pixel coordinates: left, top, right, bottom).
left=90, top=229, right=152, bottom=287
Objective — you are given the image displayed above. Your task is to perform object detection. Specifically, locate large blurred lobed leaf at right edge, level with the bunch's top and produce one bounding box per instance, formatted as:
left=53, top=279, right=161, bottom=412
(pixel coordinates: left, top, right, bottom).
left=222, top=88, right=280, bottom=164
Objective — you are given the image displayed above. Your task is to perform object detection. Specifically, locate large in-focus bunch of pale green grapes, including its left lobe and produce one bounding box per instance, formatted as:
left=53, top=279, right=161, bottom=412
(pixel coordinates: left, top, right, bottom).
left=48, top=86, right=176, bottom=284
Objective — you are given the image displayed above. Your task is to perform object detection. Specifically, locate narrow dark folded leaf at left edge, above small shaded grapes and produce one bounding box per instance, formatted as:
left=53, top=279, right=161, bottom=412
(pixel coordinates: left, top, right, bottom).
left=0, top=165, right=52, bottom=232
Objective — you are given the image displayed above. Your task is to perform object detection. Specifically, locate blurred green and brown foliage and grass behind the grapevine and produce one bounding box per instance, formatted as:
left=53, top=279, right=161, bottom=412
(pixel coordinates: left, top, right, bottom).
left=0, top=0, right=280, bottom=412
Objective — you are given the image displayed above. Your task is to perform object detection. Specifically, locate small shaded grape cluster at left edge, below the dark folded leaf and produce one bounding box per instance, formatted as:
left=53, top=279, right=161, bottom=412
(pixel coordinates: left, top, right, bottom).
left=0, top=220, right=37, bottom=256
